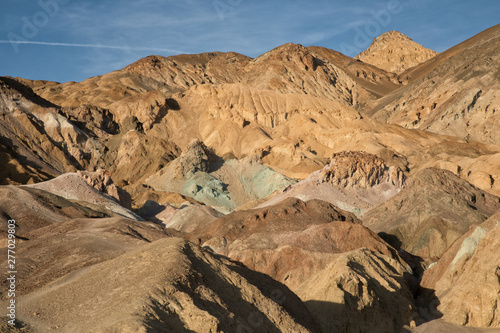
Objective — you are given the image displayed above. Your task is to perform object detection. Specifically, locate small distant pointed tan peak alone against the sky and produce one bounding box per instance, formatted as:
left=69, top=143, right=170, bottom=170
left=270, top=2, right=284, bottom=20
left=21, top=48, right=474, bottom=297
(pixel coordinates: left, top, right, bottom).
left=355, top=31, right=437, bottom=74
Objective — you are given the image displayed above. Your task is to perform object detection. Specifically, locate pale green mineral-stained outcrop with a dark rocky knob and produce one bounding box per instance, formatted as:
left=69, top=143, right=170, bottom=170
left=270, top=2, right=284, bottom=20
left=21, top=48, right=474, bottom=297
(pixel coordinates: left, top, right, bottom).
left=146, top=140, right=295, bottom=211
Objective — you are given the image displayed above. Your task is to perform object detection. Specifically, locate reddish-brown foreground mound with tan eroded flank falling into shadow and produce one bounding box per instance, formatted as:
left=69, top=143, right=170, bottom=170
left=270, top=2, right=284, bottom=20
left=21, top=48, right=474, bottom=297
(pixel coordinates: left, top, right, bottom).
left=186, top=198, right=418, bottom=331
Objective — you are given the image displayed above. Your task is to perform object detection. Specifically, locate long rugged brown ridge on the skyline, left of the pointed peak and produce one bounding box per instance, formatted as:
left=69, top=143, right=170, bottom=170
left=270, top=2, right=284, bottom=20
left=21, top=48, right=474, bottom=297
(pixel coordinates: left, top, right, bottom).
left=18, top=44, right=362, bottom=113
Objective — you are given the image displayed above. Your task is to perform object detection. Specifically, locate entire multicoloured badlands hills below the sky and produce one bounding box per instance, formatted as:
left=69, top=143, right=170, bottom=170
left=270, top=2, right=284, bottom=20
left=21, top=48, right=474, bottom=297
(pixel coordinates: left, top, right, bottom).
left=0, top=25, right=500, bottom=333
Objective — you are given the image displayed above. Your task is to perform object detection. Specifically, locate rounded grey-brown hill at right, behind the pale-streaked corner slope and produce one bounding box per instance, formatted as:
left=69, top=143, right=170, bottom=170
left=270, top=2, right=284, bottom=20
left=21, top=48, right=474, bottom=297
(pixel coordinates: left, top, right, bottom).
left=362, top=169, right=500, bottom=259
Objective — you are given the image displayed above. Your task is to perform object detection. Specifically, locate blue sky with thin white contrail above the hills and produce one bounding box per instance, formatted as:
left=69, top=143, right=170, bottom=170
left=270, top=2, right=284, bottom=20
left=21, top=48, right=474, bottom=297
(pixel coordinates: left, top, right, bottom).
left=0, top=0, right=500, bottom=82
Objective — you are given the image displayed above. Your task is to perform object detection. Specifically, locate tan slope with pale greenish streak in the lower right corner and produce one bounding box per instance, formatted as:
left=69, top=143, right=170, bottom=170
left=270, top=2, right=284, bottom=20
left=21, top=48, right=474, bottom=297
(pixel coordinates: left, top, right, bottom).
left=422, top=211, right=500, bottom=328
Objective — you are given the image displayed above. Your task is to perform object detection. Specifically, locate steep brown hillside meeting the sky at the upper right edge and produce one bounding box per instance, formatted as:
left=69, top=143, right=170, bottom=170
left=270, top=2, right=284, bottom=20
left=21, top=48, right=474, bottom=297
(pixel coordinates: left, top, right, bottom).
left=370, top=26, right=500, bottom=145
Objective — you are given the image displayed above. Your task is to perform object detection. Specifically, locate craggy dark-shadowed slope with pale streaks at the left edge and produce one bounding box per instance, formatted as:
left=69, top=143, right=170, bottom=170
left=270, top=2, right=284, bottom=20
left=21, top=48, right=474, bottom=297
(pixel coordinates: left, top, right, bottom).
left=0, top=74, right=179, bottom=189
